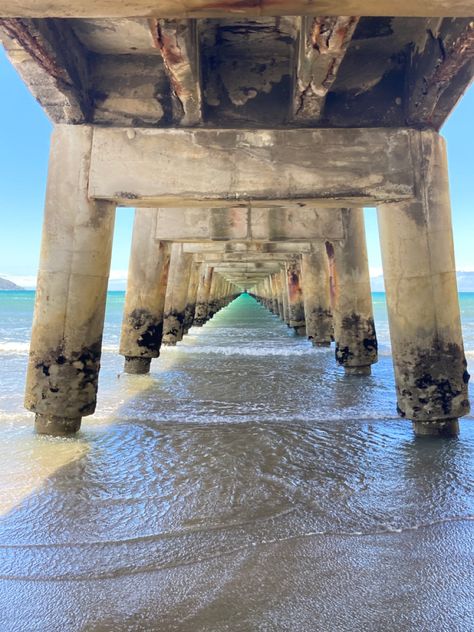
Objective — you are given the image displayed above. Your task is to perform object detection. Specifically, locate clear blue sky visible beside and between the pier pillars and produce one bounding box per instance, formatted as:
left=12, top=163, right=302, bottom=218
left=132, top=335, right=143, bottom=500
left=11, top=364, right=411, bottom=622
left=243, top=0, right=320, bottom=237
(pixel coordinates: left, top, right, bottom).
left=0, top=47, right=474, bottom=286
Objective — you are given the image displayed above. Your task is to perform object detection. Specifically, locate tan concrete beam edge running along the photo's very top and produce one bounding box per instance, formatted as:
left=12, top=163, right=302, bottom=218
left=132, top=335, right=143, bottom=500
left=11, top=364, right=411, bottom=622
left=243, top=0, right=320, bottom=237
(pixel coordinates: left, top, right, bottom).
left=0, top=0, right=473, bottom=18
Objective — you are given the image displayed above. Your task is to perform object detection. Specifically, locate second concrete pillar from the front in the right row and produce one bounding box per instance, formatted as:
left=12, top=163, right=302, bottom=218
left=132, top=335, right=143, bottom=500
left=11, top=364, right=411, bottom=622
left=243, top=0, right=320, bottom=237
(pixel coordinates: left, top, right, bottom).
left=326, top=208, right=377, bottom=375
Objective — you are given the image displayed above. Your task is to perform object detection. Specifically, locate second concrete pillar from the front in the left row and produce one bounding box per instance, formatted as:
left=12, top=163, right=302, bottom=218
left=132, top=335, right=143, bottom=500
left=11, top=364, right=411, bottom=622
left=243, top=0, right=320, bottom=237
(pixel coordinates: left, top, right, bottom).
left=120, top=208, right=170, bottom=374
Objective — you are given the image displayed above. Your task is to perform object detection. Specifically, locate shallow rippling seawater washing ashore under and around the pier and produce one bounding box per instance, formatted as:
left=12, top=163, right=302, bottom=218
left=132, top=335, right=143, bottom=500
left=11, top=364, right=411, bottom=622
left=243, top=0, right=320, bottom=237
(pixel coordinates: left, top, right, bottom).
left=0, top=292, right=474, bottom=632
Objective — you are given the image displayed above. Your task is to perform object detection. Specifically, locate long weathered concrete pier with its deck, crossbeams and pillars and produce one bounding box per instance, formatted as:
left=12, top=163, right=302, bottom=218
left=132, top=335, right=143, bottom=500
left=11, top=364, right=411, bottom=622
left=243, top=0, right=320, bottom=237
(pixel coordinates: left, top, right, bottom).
left=0, top=0, right=474, bottom=436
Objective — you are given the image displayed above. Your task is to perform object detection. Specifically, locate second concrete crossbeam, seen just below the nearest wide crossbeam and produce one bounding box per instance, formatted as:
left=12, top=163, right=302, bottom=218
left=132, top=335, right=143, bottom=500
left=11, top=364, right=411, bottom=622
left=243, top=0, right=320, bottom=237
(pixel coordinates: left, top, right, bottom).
left=155, top=207, right=344, bottom=242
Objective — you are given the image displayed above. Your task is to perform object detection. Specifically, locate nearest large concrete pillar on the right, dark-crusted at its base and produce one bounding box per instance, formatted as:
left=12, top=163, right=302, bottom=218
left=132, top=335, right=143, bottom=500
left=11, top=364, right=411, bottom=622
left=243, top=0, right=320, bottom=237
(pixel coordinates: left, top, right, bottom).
left=378, top=131, right=469, bottom=435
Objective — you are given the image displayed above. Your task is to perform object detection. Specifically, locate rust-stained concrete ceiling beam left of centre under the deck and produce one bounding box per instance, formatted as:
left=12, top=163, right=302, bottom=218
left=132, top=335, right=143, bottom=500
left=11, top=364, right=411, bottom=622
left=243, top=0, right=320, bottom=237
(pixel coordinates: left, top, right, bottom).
left=150, top=19, right=202, bottom=127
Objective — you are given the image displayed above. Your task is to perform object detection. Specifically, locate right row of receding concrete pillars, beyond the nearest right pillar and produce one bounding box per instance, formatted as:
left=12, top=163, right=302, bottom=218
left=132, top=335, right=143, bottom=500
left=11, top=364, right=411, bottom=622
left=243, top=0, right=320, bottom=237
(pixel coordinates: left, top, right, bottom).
left=254, top=208, right=377, bottom=375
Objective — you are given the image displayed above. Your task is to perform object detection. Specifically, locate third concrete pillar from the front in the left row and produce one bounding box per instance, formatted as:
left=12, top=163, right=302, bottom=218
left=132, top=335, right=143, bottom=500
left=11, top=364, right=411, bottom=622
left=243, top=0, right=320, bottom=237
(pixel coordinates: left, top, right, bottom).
left=163, top=243, right=193, bottom=345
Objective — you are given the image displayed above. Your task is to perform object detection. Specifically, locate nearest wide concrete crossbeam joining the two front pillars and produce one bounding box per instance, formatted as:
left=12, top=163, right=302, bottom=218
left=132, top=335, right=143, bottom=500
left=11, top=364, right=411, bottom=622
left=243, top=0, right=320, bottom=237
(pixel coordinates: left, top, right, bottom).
left=88, top=127, right=414, bottom=206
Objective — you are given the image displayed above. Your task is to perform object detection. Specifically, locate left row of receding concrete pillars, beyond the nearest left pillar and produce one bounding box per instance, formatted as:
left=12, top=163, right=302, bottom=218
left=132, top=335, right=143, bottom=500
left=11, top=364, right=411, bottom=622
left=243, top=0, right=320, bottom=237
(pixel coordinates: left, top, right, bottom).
left=120, top=232, right=240, bottom=374
